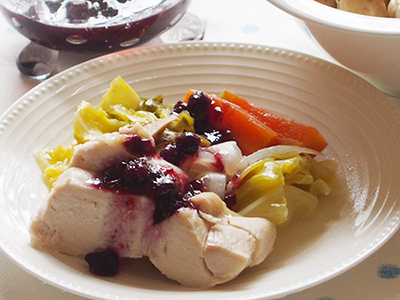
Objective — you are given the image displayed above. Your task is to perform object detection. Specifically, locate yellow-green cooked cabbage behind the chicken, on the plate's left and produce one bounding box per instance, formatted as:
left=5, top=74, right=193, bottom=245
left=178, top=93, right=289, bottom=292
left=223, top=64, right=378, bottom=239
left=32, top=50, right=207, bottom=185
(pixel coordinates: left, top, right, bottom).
left=34, top=77, right=178, bottom=189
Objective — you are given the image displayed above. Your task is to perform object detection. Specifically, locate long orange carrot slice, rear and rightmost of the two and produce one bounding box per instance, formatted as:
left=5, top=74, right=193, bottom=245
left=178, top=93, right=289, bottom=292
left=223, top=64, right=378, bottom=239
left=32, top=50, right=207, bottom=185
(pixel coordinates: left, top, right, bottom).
left=221, top=90, right=327, bottom=151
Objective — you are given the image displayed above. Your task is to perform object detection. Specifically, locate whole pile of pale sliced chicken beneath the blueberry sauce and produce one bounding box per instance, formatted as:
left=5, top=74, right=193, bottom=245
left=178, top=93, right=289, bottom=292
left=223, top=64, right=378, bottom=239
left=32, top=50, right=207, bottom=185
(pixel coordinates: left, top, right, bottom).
left=30, top=127, right=276, bottom=288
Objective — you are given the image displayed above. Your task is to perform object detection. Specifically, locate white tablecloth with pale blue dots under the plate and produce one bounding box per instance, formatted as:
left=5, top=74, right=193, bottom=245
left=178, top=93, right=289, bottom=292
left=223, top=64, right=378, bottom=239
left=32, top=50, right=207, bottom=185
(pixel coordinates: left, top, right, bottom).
left=0, top=0, right=400, bottom=300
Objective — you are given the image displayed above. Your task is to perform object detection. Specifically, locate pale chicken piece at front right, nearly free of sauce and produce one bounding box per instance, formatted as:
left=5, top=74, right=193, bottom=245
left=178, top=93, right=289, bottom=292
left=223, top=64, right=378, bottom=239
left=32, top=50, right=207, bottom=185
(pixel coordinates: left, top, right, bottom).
left=148, top=193, right=276, bottom=287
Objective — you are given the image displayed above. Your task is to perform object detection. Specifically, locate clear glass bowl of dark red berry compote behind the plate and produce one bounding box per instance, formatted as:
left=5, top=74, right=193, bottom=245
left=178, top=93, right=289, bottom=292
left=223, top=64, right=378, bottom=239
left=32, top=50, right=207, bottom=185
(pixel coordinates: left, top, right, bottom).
left=0, top=0, right=191, bottom=52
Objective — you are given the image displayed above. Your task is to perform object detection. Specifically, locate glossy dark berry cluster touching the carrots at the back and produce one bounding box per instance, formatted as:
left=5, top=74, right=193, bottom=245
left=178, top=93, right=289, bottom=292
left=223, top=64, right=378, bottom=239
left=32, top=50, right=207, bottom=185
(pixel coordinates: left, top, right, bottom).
left=174, top=91, right=234, bottom=144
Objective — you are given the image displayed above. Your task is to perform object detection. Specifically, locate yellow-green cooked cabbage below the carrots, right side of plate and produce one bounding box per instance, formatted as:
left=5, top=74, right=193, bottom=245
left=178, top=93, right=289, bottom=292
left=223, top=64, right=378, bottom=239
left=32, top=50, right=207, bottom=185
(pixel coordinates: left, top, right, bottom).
left=228, top=146, right=335, bottom=224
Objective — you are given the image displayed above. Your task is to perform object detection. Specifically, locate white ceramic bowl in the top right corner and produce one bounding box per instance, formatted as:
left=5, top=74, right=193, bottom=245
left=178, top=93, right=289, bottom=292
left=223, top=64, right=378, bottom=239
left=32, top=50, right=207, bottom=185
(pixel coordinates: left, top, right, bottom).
left=267, top=0, right=400, bottom=97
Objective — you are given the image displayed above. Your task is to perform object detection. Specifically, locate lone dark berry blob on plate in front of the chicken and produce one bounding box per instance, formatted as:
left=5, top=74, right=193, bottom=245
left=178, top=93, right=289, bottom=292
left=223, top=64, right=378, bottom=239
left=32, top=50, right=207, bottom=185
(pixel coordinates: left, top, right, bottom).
left=85, top=249, right=119, bottom=276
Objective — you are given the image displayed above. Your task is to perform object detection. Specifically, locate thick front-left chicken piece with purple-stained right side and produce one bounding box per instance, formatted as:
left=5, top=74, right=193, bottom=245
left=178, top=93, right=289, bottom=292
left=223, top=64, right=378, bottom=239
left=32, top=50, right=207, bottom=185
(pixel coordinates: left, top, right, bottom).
left=30, top=168, right=154, bottom=258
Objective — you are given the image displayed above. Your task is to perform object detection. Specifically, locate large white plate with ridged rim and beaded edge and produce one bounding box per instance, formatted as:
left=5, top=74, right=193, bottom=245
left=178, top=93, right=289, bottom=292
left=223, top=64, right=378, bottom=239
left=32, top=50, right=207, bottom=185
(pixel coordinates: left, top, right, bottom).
left=0, top=43, right=400, bottom=300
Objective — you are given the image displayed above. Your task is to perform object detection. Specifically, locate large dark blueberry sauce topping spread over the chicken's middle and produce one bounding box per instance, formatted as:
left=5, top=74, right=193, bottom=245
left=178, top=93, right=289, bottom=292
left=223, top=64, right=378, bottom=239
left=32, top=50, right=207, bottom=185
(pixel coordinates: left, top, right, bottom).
left=92, top=133, right=200, bottom=224
